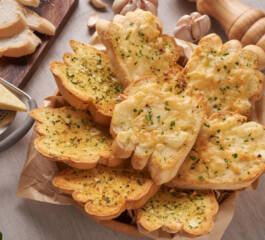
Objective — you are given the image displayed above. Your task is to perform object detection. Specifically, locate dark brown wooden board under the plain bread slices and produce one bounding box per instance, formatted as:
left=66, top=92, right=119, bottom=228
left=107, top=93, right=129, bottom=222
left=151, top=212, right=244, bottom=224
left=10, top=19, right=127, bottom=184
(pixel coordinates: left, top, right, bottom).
left=0, top=0, right=78, bottom=88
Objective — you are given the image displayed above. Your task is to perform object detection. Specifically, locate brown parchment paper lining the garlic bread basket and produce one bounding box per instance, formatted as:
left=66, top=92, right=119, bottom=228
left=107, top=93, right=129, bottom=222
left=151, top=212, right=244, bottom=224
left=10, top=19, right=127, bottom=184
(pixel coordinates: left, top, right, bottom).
left=17, top=90, right=265, bottom=240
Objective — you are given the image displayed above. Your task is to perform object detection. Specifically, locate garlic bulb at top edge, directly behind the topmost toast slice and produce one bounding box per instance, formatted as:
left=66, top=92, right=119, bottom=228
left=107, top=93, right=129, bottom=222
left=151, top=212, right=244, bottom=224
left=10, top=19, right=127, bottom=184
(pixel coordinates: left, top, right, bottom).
left=112, top=0, right=158, bottom=15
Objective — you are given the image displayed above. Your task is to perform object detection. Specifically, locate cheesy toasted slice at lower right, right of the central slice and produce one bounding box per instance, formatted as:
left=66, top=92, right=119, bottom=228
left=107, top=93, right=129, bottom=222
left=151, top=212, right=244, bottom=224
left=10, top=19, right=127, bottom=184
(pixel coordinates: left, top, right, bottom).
left=169, top=112, right=265, bottom=190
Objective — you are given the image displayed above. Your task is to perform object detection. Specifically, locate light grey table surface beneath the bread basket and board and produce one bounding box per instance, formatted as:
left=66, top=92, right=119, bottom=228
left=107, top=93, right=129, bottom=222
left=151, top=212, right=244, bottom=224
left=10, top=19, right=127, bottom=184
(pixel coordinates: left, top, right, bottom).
left=0, top=0, right=265, bottom=240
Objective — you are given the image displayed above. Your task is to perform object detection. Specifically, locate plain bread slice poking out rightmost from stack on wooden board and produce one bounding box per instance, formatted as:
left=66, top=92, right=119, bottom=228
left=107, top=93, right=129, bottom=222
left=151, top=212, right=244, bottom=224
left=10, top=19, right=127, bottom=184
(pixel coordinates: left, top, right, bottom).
left=21, top=8, right=56, bottom=36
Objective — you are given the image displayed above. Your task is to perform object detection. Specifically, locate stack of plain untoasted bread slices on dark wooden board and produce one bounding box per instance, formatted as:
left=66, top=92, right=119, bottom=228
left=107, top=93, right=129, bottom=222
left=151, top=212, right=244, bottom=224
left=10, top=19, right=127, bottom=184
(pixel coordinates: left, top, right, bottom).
left=0, top=0, right=55, bottom=57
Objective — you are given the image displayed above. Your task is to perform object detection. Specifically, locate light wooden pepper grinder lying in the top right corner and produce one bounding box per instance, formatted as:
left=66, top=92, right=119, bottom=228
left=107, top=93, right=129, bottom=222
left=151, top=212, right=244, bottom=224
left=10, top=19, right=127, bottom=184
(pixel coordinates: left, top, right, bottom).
left=189, top=0, right=265, bottom=69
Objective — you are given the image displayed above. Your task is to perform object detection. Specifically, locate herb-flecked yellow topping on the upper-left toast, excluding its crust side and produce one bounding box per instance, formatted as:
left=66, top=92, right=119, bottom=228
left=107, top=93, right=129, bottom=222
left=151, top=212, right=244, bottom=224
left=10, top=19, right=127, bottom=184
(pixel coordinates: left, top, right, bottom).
left=52, top=41, right=123, bottom=114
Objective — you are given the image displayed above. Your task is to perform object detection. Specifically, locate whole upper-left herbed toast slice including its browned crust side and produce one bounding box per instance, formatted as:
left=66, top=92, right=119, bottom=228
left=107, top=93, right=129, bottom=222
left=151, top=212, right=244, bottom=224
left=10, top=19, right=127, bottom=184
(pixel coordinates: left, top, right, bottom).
left=50, top=41, right=123, bottom=125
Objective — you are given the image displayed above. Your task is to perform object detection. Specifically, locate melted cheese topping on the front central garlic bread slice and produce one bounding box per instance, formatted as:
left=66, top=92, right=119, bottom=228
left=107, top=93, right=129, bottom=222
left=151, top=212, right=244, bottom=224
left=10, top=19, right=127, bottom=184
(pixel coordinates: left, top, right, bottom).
left=111, top=79, right=204, bottom=169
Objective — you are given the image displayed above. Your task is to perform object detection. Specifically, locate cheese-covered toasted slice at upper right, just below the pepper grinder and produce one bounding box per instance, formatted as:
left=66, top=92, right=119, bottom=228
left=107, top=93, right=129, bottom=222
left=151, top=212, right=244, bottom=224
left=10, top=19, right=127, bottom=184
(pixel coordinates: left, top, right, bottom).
left=184, top=34, right=264, bottom=116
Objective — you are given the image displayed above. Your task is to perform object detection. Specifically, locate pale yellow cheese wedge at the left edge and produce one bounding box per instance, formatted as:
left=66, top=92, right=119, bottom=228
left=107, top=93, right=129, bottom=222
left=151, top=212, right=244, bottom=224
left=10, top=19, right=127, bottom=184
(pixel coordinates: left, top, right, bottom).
left=0, top=84, right=27, bottom=112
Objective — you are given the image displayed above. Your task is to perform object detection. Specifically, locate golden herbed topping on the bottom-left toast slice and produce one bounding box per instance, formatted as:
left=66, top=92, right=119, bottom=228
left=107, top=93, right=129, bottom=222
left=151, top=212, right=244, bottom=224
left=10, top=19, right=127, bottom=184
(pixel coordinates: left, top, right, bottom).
left=54, top=165, right=152, bottom=210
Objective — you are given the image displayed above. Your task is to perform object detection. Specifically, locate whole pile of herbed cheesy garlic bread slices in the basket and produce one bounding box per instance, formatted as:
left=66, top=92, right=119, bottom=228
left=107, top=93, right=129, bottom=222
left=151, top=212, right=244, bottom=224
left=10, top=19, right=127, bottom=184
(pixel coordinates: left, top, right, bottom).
left=31, top=10, right=265, bottom=237
